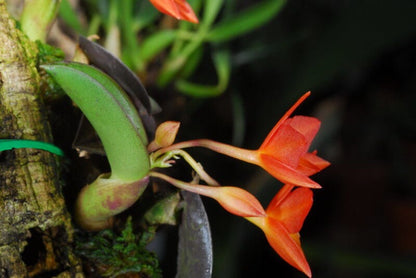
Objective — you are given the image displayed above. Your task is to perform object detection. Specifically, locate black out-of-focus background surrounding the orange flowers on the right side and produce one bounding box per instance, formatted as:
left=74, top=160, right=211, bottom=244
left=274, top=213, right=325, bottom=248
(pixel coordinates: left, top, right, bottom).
left=155, top=0, right=416, bottom=278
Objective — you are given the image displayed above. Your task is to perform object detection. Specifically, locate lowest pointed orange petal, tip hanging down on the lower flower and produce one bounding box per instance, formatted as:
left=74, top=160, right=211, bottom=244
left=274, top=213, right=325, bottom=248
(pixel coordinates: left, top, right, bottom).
left=263, top=217, right=312, bottom=277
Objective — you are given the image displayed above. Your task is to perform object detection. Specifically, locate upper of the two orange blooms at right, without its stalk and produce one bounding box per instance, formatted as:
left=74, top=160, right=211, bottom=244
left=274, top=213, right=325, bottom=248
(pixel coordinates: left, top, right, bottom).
left=256, top=92, right=330, bottom=188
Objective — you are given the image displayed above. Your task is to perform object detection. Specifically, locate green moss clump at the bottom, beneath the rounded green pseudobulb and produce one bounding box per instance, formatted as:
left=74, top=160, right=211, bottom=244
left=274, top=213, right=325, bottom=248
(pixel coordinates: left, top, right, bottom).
left=76, top=217, right=162, bottom=278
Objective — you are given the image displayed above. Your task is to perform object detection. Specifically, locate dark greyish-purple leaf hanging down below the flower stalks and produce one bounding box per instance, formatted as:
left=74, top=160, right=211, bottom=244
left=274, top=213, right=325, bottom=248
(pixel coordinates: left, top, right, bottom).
left=176, top=191, right=212, bottom=278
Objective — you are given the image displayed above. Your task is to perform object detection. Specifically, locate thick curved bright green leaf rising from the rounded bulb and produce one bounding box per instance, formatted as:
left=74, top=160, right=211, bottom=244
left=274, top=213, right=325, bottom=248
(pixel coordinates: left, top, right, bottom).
left=42, top=63, right=150, bottom=182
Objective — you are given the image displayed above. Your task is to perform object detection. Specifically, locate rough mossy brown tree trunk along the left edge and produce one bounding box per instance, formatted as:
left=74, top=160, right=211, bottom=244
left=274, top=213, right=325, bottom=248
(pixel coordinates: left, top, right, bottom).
left=0, top=0, right=83, bottom=277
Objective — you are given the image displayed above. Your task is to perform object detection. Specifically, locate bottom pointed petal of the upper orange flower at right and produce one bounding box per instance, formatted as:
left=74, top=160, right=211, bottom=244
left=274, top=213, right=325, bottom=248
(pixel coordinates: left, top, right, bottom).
left=259, top=153, right=321, bottom=188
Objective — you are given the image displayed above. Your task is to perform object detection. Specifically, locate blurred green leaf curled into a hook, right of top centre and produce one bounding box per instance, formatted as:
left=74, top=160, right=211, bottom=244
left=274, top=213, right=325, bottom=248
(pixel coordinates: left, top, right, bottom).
left=175, top=50, right=231, bottom=97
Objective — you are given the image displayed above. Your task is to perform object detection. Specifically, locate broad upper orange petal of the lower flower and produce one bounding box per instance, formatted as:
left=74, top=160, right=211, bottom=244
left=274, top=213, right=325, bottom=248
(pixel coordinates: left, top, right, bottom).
left=266, top=188, right=313, bottom=234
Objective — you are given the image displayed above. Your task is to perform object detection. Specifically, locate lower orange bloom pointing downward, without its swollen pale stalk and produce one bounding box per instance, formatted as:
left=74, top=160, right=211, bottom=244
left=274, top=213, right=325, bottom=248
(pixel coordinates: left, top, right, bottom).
left=246, top=185, right=313, bottom=277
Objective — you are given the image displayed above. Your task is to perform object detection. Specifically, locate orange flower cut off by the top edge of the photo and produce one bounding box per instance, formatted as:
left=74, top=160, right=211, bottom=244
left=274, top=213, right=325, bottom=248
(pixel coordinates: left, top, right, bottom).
left=150, top=0, right=198, bottom=23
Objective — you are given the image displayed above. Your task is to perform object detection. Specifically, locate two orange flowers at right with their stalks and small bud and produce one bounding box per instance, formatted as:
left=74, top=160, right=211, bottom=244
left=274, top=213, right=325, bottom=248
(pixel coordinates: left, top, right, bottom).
left=148, top=92, right=330, bottom=277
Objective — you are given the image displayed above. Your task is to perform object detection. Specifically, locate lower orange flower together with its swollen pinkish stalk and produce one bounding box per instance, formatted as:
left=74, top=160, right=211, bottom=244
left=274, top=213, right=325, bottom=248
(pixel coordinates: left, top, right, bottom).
left=149, top=169, right=313, bottom=277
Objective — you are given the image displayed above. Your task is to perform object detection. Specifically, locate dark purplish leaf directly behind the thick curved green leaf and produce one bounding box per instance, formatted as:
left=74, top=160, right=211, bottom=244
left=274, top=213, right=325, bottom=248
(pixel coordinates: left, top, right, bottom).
left=79, top=36, right=156, bottom=137
